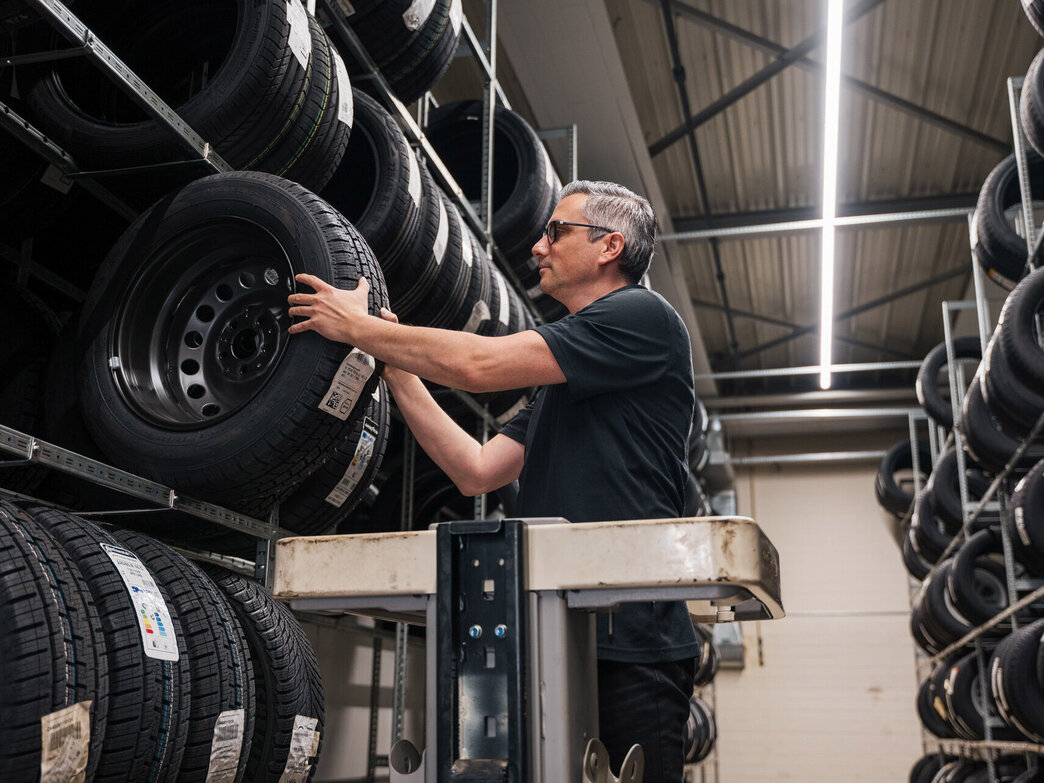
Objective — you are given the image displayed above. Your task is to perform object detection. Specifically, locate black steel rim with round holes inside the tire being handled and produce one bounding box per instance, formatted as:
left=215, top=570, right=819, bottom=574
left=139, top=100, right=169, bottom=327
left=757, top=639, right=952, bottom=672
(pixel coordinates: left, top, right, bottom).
left=109, top=218, right=293, bottom=429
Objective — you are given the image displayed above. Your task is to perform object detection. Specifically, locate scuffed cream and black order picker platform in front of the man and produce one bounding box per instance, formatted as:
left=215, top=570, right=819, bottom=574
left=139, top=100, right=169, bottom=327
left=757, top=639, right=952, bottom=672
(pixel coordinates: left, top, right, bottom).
left=272, top=517, right=783, bottom=783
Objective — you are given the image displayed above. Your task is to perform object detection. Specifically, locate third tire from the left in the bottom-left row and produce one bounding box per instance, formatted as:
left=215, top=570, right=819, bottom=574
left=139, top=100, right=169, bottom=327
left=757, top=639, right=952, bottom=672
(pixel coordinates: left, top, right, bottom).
left=105, top=526, right=255, bottom=783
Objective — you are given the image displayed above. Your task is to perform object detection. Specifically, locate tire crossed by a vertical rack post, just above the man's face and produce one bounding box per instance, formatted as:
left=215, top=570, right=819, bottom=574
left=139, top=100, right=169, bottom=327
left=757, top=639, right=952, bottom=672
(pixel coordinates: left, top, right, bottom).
left=427, top=100, right=562, bottom=269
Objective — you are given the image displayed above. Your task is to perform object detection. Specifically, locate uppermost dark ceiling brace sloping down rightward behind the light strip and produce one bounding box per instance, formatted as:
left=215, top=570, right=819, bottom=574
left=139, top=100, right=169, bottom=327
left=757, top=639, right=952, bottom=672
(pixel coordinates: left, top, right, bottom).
left=646, top=0, right=1012, bottom=155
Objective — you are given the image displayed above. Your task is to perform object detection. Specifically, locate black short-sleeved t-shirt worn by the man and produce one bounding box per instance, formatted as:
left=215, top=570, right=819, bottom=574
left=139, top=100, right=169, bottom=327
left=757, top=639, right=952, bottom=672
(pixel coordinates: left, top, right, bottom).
left=501, top=285, right=698, bottom=663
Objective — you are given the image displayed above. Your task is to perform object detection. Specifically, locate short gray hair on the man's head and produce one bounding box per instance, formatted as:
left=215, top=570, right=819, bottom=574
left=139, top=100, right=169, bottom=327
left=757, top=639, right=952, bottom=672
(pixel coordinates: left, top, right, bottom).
left=561, top=180, right=656, bottom=283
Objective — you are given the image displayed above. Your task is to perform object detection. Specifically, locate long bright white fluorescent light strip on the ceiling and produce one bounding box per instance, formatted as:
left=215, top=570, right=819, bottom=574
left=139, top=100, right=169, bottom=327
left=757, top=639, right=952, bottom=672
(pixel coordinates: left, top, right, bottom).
left=820, top=0, right=845, bottom=388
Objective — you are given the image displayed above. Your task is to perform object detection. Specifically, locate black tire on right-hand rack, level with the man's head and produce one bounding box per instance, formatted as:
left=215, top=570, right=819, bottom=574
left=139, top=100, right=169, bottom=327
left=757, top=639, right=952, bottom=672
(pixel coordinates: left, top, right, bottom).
left=973, top=150, right=1044, bottom=290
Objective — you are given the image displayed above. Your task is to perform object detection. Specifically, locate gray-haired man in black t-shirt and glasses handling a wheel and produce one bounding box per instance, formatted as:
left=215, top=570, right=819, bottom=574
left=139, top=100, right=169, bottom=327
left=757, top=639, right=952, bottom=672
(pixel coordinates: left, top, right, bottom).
left=289, top=181, right=699, bottom=783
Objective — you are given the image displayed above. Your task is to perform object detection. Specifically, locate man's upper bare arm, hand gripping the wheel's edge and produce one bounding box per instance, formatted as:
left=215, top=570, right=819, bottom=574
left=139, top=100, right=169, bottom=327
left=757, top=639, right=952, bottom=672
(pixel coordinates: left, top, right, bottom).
left=288, top=275, right=566, bottom=393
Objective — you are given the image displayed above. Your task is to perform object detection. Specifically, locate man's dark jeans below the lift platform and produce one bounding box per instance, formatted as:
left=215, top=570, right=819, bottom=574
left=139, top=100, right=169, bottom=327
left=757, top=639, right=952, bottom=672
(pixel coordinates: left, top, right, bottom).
left=598, top=658, right=696, bottom=783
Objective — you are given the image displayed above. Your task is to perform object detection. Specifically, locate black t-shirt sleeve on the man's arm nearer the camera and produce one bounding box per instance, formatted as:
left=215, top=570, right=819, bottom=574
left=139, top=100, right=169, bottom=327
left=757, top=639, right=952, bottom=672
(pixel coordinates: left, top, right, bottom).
left=536, top=289, right=672, bottom=400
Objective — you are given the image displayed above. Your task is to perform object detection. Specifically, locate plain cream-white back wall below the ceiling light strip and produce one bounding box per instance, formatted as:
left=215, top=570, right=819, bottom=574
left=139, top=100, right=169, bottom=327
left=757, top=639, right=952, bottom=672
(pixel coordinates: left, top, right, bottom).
left=715, top=457, right=921, bottom=783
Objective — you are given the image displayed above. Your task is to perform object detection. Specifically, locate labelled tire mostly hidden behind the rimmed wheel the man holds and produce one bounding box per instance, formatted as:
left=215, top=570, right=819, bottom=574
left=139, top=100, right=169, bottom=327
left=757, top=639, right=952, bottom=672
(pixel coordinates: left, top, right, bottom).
left=279, top=383, right=392, bottom=536
